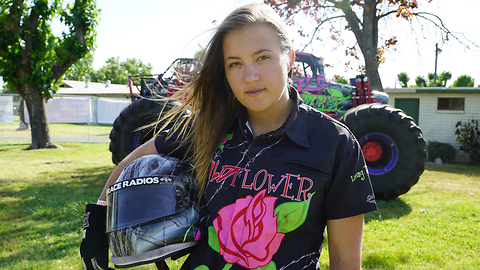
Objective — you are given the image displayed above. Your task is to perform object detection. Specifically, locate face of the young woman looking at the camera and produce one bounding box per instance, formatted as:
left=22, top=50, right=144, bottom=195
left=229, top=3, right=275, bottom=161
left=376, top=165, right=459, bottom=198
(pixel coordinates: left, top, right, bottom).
left=222, top=24, right=294, bottom=117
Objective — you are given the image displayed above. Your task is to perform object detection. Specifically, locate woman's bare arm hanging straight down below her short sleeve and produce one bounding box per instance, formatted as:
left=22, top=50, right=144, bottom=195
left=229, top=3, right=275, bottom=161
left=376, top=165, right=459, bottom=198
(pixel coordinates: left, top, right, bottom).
left=327, top=214, right=363, bottom=269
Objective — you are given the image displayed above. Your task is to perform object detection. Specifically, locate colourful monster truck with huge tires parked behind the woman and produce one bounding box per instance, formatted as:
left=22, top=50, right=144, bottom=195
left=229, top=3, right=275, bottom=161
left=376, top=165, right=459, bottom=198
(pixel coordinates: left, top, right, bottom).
left=110, top=52, right=427, bottom=200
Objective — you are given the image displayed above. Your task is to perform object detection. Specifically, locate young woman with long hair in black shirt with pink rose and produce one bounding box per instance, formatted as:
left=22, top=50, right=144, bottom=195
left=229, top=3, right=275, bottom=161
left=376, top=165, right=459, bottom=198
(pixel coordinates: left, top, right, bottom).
left=81, top=4, right=376, bottom=270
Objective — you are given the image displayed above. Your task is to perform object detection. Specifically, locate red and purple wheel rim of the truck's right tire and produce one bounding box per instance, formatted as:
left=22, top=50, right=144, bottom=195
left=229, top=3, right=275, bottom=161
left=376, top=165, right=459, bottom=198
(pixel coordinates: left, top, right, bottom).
left=359, top=133, right=398, bottom=175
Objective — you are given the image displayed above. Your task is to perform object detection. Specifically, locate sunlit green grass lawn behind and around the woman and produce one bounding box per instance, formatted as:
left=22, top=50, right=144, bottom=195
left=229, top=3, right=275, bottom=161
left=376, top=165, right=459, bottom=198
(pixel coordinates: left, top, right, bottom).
left=0, top=143, right=480, bottom=270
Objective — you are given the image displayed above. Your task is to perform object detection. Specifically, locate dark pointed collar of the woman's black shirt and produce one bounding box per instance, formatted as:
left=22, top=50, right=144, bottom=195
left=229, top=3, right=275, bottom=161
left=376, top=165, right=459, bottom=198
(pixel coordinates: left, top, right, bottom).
left=234, top=87, right=310, bottom=148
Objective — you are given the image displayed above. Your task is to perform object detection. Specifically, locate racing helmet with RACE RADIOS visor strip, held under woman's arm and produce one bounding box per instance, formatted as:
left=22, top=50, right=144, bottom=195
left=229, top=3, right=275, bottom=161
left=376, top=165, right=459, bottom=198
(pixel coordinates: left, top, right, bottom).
left=106, top=155, right=200, bottom=268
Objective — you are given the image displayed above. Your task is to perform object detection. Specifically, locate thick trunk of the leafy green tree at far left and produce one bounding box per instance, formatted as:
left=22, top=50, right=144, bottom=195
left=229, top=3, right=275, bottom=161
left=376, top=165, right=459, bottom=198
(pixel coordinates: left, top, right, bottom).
left=23, top=85, right=60, bottom=149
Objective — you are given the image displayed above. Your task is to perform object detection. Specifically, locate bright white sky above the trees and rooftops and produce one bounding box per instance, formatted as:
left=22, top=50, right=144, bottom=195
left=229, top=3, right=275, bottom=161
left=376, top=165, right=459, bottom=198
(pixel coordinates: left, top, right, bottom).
left=72, top=0, right=480, bottom=88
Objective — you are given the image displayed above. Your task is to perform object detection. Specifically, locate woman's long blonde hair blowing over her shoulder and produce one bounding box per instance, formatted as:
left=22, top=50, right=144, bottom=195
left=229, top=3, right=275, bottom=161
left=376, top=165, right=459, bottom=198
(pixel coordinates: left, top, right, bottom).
left=160, top=4, right=292, bottom=195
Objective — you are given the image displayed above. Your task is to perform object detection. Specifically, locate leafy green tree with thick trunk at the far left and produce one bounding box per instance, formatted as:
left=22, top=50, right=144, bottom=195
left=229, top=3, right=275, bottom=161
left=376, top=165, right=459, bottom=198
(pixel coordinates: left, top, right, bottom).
left=0, top=0, right=98, bottom=149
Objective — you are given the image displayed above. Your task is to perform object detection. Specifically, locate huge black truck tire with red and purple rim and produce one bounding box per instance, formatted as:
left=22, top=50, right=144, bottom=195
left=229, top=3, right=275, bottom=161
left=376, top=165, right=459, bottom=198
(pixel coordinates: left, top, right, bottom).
left=339, top=103, right=427, bottom=200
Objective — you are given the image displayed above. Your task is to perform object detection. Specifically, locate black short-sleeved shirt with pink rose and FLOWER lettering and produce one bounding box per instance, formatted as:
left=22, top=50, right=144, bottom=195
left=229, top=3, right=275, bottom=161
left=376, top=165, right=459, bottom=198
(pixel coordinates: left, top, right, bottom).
left=157, top=89, right=376, bottom=270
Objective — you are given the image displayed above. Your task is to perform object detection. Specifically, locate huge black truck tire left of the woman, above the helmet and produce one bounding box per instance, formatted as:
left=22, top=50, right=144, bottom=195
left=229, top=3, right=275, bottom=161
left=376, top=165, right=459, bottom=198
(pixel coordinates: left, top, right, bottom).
left=110, top=98, right=179, bottom=164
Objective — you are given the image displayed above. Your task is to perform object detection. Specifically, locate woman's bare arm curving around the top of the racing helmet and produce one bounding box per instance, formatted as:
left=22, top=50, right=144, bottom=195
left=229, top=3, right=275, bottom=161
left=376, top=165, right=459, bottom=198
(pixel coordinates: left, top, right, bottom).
left=98, top=137, right=158, bottom=201
